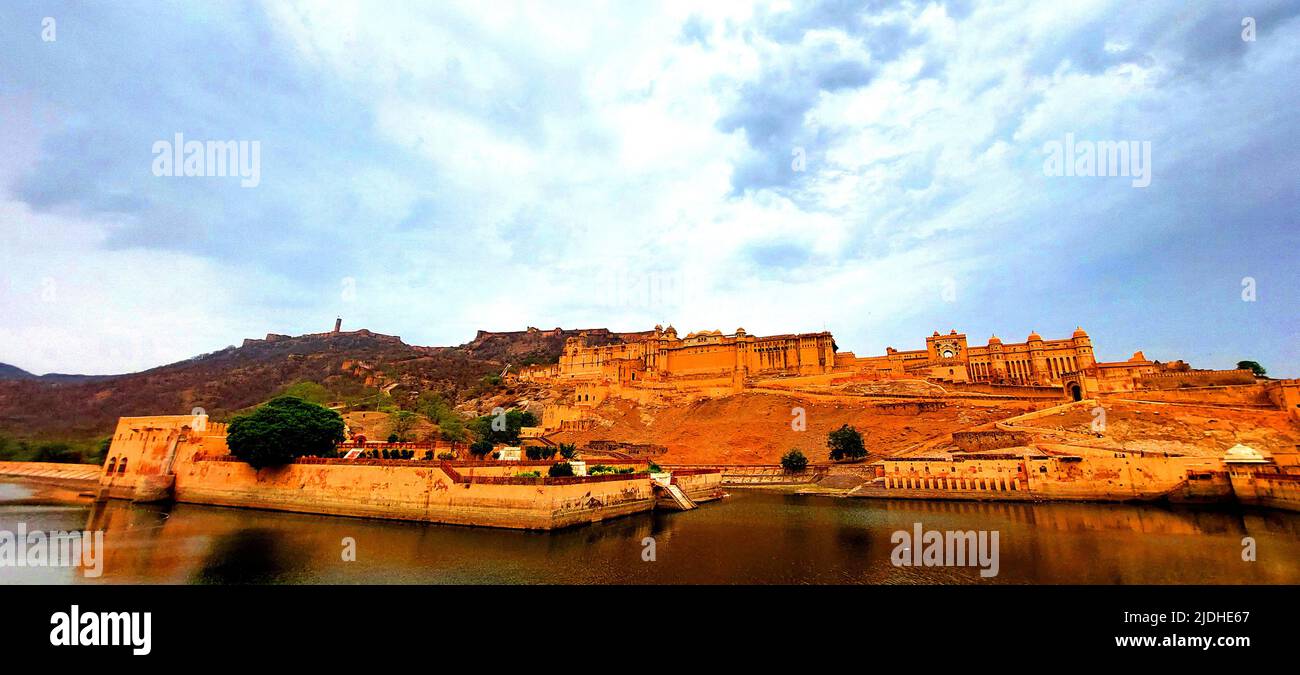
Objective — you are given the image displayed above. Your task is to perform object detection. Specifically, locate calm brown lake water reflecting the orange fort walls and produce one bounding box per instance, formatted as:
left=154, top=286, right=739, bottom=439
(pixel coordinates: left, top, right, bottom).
left=0, top=484, right=1300, bottom=584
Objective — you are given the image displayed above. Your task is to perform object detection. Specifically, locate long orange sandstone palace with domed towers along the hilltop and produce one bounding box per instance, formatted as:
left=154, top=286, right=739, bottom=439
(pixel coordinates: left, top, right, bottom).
left=519, top=325, right=1255, bottom=404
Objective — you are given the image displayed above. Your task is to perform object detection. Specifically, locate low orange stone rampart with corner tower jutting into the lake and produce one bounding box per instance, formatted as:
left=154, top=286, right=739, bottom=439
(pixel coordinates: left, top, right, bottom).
left=100, top=415, right=722, bottom=529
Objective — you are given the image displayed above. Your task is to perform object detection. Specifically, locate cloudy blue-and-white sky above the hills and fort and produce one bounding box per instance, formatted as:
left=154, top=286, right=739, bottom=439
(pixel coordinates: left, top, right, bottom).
left=0, top=0, right=1300, bottom=377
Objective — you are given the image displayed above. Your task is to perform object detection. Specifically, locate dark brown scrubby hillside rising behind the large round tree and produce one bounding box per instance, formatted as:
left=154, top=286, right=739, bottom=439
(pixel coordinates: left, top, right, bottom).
left=0, top=329, right=634, bottom=440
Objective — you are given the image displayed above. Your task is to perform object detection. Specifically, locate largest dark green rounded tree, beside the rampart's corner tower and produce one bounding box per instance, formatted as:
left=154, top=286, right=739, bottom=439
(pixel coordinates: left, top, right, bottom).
left=226, top=397, right=343, bottom=468
